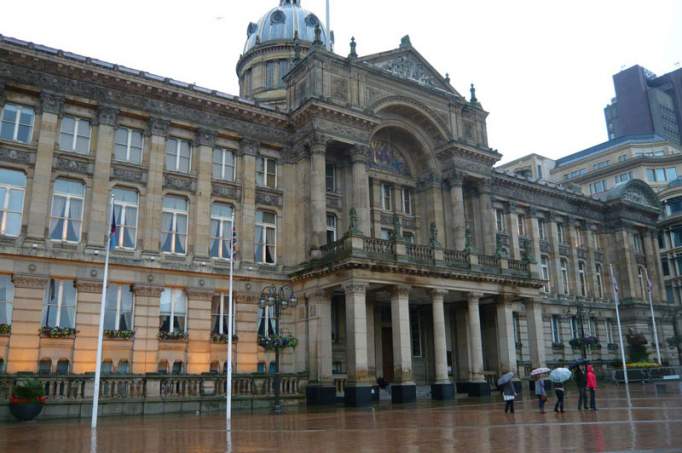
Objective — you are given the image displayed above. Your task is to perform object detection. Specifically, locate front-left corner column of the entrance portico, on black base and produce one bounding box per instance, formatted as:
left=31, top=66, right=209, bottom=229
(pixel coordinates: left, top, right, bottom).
left=344, top=282, right=372, bottom=406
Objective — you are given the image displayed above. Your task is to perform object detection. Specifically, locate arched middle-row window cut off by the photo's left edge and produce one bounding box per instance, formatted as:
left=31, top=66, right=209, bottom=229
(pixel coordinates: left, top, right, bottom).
left=0, top=168, right=26, bottom=237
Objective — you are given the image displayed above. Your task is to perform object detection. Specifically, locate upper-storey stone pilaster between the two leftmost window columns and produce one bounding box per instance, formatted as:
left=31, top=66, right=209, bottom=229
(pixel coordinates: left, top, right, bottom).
left=26, top=92, right=64, bottom=242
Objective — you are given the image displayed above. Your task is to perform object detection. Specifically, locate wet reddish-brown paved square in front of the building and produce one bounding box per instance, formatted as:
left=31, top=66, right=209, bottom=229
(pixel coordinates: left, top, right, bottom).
left=0, top=386, right=682, bottom=453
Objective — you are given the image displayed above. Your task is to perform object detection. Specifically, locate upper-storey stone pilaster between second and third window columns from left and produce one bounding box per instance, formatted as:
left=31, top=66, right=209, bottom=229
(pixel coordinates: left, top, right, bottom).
left=88, top=106, right=118, bottom=247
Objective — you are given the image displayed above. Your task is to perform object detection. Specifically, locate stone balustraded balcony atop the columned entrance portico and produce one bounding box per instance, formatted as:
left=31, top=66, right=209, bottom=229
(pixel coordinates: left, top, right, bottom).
left=294, top=234, right=543, bottom=287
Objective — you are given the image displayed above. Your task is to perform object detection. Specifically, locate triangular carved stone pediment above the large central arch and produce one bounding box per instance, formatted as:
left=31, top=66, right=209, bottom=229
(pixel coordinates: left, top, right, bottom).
left=360, top=46, right=460, bottom=96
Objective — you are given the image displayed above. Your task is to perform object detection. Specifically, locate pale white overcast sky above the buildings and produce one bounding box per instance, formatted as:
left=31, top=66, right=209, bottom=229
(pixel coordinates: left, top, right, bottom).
left=0, top=0, right=682, bottom=161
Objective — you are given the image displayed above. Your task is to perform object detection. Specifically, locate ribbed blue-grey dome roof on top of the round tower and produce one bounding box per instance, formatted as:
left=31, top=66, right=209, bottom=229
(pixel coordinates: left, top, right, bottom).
left=244, top=0, right=332, bottom=53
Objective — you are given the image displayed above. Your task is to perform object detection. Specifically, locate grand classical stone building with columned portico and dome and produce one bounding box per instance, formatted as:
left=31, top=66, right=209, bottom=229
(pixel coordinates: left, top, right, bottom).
left=0, top=0, right=676, bottom=405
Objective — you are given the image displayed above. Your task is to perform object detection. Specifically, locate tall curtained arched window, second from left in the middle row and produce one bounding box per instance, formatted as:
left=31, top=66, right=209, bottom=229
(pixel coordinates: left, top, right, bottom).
left=50, top=178, right=85, bottom=242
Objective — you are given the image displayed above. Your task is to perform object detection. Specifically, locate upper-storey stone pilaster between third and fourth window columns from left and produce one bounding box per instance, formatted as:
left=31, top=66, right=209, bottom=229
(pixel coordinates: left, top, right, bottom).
left=140, top=118, right=169, bottom=254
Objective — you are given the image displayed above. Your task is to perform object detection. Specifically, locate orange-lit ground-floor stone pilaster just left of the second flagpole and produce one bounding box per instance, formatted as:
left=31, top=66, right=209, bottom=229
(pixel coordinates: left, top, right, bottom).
left=187, top=288, right=211, bottom=374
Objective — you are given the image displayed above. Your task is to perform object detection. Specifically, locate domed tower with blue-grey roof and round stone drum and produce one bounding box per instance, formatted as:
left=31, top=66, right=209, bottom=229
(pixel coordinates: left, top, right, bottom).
left=237, top=0, right=333, bottom=106
